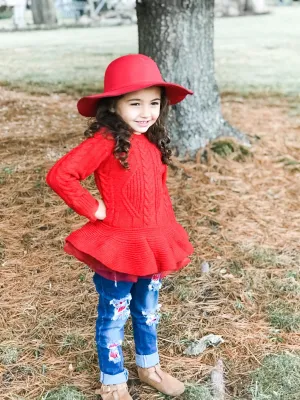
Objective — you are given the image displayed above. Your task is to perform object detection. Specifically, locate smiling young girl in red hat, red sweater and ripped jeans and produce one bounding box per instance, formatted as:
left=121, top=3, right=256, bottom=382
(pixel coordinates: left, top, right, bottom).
left=47, top=54, right=193, bottom=400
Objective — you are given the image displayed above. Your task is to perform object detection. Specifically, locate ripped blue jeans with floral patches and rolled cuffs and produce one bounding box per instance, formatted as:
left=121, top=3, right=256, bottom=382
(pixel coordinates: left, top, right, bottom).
left=94, top=273, right=161, bottom=385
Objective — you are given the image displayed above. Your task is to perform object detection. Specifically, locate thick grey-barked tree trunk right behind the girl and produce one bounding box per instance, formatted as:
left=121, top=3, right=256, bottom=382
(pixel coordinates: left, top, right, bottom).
left=137, top=0, right=247, bottom=157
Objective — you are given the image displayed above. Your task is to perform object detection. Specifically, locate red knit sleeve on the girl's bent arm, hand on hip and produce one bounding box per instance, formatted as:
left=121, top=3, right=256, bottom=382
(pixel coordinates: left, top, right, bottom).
left=46, top=133, right=113, bottom=222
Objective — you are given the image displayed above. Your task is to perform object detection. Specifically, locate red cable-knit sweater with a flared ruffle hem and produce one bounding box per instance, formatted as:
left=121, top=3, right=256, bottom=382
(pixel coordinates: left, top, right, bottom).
left=46, top=131, right=193, bottom=281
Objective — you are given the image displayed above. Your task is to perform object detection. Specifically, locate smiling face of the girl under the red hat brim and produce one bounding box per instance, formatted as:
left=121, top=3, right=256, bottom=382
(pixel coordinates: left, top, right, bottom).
left=116, top=86, right=161, bottom=135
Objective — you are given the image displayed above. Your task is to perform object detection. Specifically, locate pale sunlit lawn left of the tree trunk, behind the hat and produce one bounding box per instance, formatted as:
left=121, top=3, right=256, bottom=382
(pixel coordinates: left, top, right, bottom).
left=0, top=27, right=137, bottom=96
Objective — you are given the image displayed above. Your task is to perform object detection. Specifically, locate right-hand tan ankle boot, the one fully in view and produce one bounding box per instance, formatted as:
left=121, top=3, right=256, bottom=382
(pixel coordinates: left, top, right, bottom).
left=138, top=364, right=184, bottom=396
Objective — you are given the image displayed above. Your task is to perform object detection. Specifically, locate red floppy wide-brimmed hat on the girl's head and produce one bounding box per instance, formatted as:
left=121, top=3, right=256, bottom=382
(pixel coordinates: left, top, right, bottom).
left=77, top=54, right=193, bottom=117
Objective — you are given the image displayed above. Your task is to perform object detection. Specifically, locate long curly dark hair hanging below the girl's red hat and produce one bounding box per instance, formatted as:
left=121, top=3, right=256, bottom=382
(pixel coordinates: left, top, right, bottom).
left=84, top=88, right=172, bottom=169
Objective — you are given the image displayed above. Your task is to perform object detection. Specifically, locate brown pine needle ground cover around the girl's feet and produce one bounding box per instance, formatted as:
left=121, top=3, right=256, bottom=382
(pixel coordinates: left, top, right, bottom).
left=0, top=88, right=300, bottom=400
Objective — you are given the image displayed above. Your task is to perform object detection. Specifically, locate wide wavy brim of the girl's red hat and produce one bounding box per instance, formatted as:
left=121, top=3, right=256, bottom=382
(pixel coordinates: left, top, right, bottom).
left=77, top=81, right=193, bottom=117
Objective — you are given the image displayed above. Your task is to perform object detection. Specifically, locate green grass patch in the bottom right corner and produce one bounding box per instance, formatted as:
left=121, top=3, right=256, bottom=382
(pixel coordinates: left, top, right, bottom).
left=250, top=354, right=300, bottom=400
